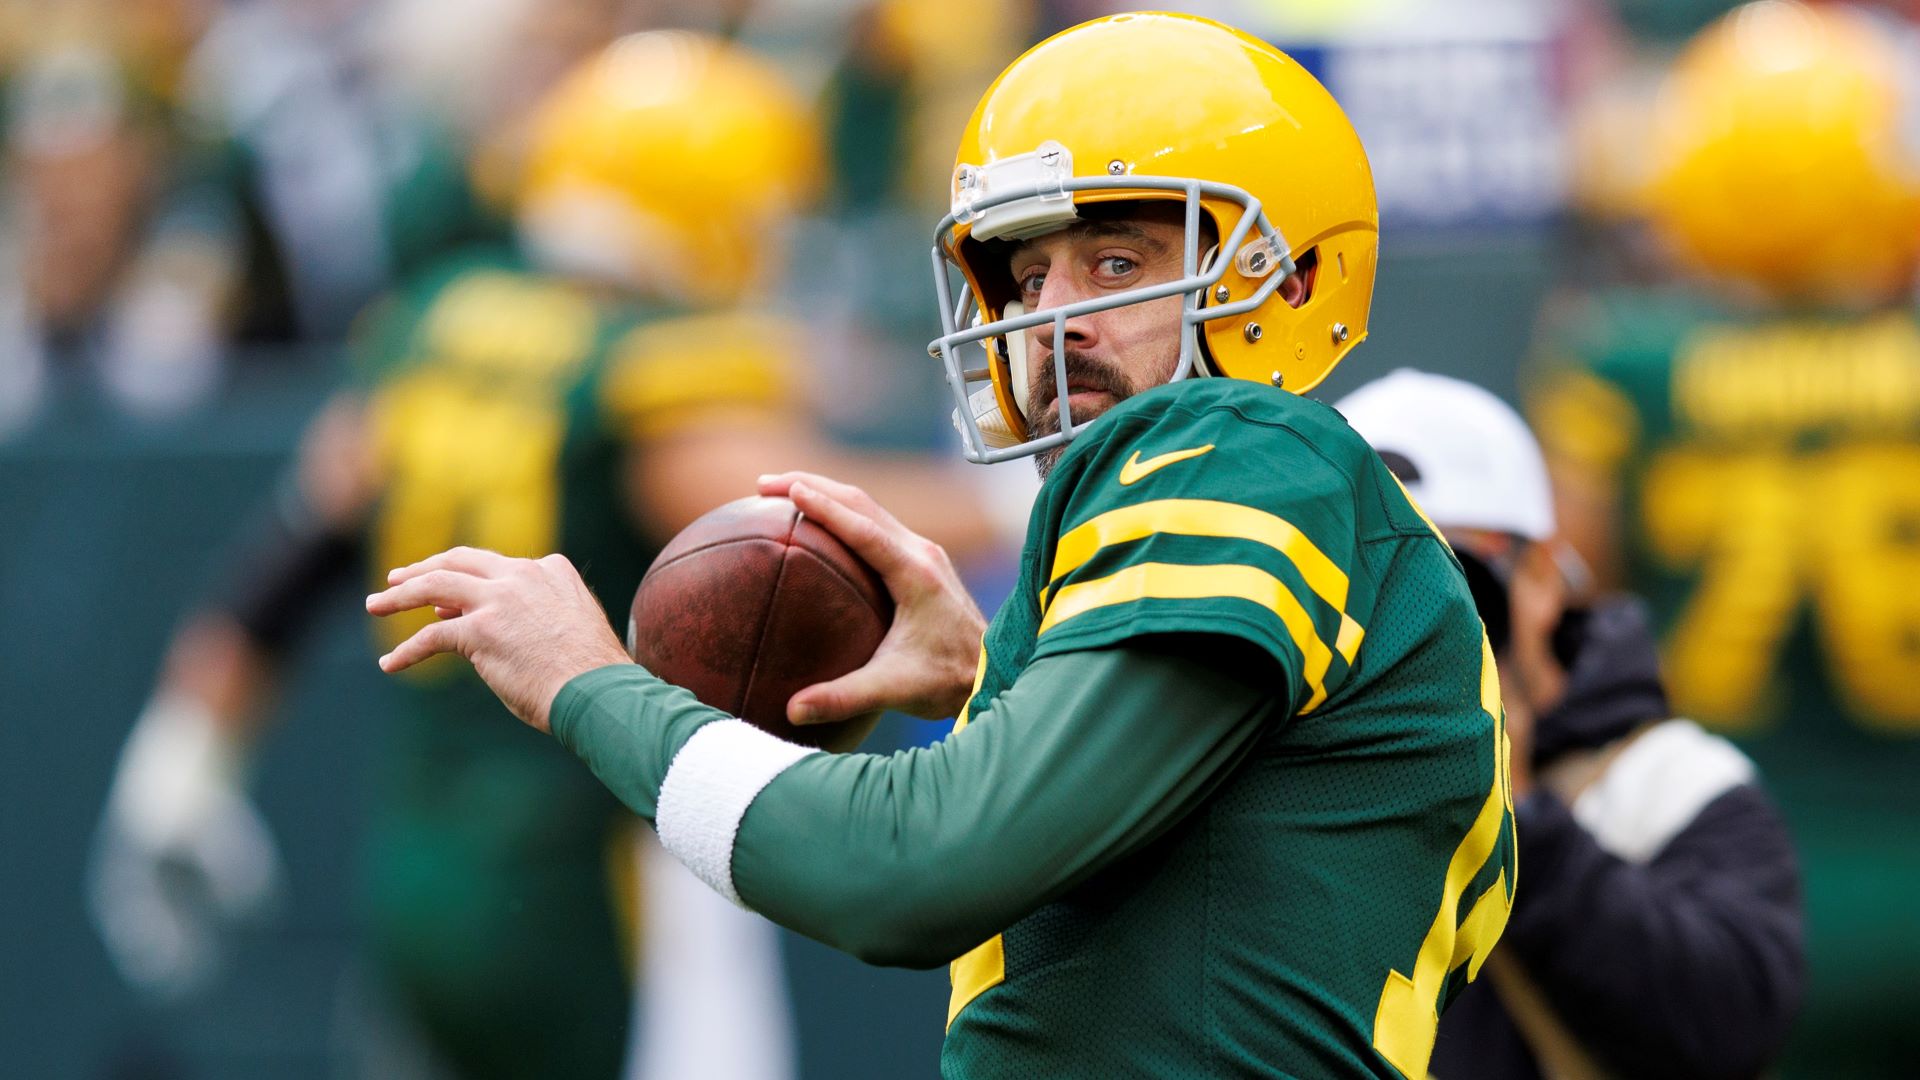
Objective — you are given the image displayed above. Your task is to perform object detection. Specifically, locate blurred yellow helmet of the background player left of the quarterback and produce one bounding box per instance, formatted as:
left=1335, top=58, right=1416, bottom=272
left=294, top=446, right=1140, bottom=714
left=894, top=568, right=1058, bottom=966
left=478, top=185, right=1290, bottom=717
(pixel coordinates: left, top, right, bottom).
left=515, top=31, right=822, bottom=302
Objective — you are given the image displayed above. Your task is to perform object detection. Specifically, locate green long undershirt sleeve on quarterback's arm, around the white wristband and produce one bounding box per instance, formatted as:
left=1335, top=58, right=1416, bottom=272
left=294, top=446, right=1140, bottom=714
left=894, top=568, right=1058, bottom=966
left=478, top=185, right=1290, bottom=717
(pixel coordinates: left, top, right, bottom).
left=553, top=640, right=1284, bottom=967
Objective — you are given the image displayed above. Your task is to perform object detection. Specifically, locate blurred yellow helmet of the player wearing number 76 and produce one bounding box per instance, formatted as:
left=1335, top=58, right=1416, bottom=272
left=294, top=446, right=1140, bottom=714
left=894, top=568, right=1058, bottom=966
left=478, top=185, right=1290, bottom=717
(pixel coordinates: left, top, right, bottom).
left=1647, top=0, right=1920, bottom=302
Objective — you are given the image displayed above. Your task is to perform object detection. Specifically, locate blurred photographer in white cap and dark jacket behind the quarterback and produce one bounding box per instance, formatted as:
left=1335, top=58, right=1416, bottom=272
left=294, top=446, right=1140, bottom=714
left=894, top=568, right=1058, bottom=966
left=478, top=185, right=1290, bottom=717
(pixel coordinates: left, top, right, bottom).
left=1336, top=369, right=1805, bottom=1080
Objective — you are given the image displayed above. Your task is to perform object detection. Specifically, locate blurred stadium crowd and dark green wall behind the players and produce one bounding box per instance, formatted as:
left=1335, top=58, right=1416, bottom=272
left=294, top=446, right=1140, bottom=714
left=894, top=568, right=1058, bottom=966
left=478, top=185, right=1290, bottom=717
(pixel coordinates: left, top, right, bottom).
left=0, top=0, right=1920, bottom=1078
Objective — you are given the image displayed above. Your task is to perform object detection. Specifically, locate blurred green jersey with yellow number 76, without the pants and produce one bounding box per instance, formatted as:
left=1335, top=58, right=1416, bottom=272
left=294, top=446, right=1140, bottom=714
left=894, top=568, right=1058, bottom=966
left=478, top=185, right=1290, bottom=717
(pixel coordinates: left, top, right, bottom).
left=1530, top=294, right=1920, bottom=753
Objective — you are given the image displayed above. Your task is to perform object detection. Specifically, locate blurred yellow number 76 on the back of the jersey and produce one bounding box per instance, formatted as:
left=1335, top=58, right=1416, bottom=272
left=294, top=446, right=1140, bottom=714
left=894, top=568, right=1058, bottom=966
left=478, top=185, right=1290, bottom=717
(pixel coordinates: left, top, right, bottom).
left=1642, top=444, right=1920, bottom=734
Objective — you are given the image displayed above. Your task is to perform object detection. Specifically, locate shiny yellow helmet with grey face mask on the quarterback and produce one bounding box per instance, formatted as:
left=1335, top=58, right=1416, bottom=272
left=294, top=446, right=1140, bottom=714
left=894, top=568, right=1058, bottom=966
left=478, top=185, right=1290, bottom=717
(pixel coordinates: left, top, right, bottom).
left=929, top=13, right=1380, bottom=461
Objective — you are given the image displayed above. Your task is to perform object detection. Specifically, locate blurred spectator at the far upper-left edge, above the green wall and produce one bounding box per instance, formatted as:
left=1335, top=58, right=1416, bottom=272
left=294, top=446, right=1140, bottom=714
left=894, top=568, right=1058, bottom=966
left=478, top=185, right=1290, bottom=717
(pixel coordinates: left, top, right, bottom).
left=0, top=18, right=238, bottom=426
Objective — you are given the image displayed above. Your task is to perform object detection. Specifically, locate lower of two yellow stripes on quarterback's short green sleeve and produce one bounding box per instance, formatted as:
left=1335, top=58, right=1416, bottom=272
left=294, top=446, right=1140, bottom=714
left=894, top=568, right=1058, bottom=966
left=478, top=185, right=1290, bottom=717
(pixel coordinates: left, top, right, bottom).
left=1041, top=563, right=1332, bottom=713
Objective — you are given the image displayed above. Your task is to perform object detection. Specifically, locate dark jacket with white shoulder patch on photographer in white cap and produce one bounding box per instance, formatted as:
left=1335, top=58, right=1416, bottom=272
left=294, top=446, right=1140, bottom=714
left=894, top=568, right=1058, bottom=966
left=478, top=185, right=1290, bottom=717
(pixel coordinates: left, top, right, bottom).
left=1432, top=600, right=1805, bottom=1080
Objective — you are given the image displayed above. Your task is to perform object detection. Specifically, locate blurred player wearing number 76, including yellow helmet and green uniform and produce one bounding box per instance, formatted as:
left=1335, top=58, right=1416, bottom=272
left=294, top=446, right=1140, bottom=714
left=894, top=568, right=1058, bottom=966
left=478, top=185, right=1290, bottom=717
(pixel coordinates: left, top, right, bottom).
left=1532, top=2, right=1920, bottom=1076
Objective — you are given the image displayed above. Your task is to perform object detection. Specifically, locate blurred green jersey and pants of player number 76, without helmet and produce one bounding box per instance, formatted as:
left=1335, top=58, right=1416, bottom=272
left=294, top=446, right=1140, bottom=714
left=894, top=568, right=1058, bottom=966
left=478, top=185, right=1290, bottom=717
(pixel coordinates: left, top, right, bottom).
left=1530, top=292, right=1920, bottom=1076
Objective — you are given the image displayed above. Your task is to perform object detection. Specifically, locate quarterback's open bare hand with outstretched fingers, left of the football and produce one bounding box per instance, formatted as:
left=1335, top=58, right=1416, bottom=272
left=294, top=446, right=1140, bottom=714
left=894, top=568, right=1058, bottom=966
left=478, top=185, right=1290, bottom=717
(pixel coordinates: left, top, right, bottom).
left=367, top=548, right=632, bottom=732
